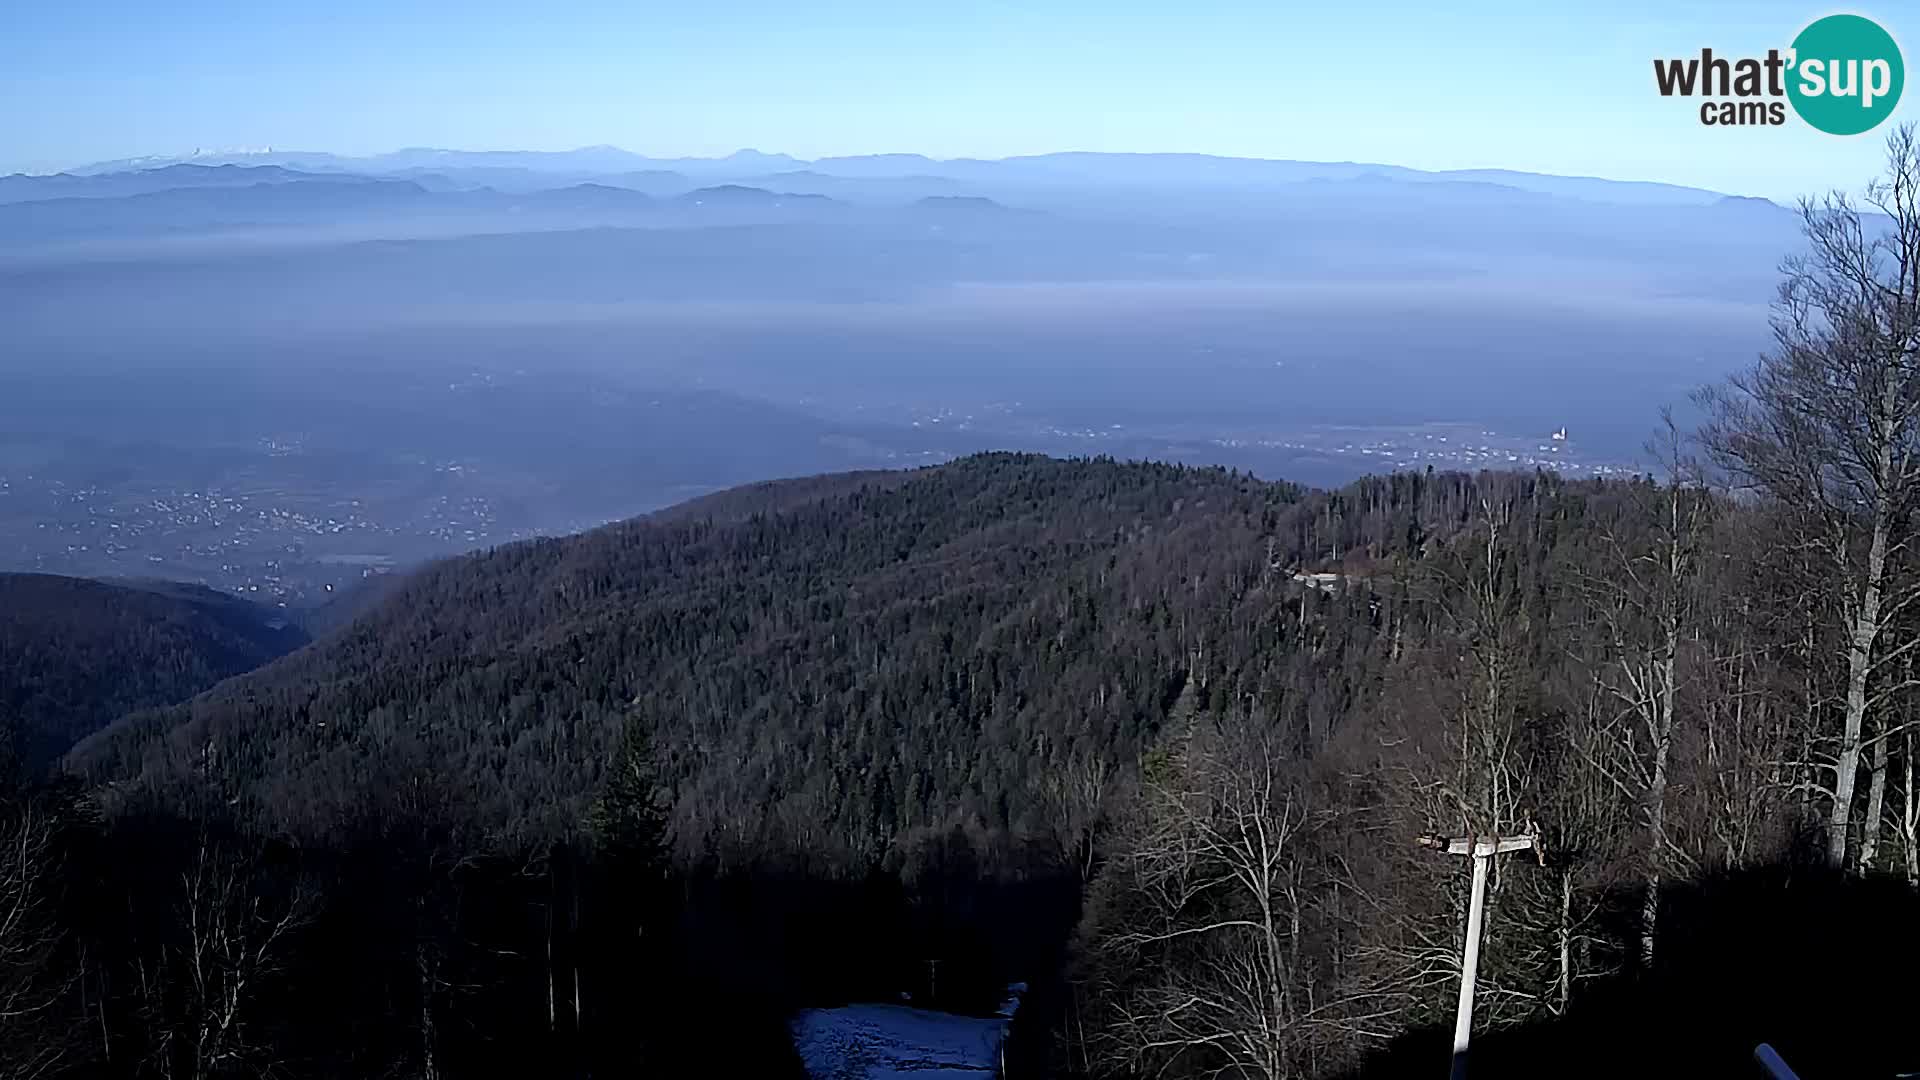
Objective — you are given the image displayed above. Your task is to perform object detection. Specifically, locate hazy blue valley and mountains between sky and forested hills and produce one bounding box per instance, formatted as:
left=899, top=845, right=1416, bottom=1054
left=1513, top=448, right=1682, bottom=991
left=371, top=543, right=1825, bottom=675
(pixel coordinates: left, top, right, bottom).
left=0, top=148, right=1795, bottom=601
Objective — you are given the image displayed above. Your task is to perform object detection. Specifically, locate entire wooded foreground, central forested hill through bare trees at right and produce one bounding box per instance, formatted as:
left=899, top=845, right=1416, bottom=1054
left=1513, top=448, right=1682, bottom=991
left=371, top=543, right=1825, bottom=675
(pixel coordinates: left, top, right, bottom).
left=11, top=133, right=1920, bottom=1078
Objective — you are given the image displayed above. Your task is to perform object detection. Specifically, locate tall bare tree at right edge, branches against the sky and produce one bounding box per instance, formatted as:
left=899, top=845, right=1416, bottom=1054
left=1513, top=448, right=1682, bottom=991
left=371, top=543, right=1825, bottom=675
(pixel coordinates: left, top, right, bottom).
left=1703, top=125, right=1920, bottom=869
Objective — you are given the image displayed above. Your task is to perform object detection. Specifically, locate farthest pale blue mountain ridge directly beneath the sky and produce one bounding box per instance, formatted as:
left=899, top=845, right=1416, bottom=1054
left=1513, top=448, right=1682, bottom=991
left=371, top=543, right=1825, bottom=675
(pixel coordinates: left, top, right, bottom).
left=26, top=146, right=1722, bottom=206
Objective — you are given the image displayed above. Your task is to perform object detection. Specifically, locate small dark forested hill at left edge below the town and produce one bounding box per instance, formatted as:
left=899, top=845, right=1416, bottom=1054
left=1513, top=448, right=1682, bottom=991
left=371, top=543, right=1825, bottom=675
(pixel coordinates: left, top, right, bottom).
left=0, top=575, right=307, bottom=769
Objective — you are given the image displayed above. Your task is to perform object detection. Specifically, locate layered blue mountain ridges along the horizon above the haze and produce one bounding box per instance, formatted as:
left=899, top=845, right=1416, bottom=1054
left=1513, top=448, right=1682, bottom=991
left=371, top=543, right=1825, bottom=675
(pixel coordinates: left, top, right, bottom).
left=0, top=146, right=1788, bottom=261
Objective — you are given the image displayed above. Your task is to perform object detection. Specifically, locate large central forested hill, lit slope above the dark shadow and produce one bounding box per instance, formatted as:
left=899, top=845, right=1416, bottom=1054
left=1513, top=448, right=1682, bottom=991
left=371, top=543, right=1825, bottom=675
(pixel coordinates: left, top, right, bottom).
left=75, top=455, right=1466, bottom=845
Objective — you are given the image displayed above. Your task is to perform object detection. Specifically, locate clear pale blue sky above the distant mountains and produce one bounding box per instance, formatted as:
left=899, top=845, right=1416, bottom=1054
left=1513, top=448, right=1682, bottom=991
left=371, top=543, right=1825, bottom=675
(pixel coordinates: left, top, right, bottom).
left=0, top=0, right=1920, bottom=198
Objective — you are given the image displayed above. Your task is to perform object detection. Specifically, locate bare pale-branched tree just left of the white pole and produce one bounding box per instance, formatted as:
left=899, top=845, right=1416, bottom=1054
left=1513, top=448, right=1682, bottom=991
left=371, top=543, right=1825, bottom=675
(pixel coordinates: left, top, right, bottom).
left=1085, top=719, right=1394, bottom=1078
